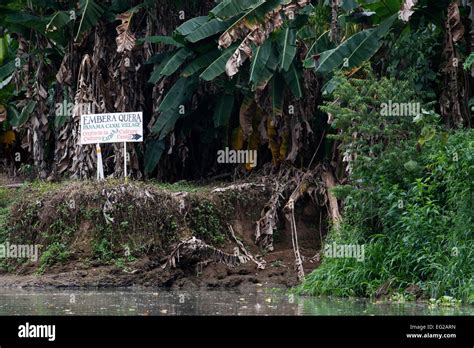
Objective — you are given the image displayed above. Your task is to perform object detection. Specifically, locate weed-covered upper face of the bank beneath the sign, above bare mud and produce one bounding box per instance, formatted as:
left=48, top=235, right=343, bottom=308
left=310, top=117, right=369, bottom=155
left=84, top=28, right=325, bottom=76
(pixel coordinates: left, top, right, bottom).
left=0, top=180, right=265, bottom=274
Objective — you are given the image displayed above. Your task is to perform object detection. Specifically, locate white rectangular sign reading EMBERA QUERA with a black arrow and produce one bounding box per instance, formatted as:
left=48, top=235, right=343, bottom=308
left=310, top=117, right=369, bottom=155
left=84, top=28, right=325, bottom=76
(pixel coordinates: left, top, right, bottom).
left=81, top=112, right=143, bottom=145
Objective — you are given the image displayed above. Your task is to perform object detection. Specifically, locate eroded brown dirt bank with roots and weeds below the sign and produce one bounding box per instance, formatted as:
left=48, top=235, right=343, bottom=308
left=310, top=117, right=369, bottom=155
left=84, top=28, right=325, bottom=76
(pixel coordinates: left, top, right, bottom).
left=0, top=182, right=324, bottom=289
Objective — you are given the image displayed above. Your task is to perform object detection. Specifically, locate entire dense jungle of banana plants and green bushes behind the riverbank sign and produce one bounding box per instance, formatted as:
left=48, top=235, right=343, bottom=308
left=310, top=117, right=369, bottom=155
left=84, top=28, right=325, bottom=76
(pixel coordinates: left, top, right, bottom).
left=0, top=0, right=474, bottom=303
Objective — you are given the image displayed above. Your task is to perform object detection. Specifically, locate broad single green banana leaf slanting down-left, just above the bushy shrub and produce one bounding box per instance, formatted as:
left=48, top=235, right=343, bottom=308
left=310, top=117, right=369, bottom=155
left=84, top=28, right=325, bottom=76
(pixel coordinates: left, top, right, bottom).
left=315, top=14, right=397, bottom=75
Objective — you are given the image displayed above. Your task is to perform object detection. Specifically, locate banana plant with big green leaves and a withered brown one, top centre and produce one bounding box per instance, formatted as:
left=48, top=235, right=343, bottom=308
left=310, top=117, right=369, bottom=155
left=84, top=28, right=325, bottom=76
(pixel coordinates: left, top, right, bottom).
left=140, top=0, right=313, bottom=170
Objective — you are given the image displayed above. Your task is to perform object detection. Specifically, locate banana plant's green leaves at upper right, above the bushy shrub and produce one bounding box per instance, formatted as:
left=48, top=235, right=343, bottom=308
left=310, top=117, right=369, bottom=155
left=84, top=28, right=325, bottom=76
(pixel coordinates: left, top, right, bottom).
left=304, top=0, right=449, bottom=93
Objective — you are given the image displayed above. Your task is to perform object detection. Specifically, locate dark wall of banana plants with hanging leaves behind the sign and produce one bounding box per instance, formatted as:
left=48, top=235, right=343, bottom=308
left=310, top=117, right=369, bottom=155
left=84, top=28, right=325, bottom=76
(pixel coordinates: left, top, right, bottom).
left=0, top=0, right=470, bottom=177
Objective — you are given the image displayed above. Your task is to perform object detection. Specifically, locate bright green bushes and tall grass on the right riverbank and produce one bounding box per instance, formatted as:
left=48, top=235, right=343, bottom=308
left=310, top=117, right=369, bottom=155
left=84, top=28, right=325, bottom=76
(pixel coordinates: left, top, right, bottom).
left=300, top=72, right=474, bottom=300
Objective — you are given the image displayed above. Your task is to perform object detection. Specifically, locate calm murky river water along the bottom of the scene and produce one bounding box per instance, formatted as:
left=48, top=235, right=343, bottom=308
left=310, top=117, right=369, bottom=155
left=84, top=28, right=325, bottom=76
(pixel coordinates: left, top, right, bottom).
left=0, top=289, right=474, bottom=316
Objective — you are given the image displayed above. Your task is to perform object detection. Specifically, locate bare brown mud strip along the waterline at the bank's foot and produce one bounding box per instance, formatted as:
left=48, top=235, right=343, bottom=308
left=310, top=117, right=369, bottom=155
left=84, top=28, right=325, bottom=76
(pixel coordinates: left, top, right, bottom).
left=0, top=249, right=317, bottom=290
